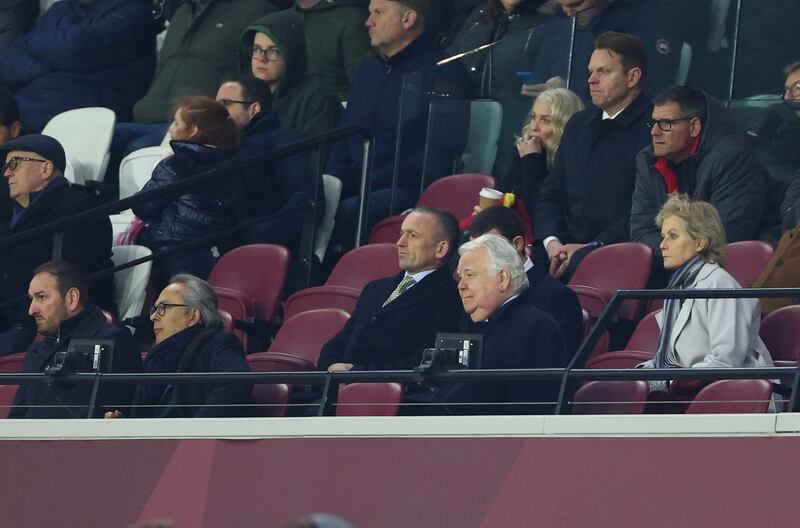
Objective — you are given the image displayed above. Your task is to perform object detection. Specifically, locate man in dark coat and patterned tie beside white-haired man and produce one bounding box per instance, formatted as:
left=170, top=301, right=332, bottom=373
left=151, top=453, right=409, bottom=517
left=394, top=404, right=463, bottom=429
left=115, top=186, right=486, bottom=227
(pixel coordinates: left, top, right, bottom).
left=317, top=207, right=461, bottom=371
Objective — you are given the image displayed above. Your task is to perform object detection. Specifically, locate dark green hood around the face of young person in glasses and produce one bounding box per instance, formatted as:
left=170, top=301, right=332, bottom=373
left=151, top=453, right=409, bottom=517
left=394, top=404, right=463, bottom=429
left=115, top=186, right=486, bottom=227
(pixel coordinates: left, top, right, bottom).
left=239, top=9, right=306, bottom=99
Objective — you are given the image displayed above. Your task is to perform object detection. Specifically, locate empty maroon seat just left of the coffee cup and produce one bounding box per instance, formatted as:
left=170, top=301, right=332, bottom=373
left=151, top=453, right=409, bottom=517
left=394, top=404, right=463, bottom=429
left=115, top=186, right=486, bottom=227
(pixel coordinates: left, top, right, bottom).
left=369, top=172, right=495, bottom=244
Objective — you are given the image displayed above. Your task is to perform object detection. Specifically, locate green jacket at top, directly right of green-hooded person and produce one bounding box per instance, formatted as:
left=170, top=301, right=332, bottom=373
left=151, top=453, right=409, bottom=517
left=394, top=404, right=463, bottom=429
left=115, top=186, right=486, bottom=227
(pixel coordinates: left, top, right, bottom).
left=294, top=0, right=372, bottom=101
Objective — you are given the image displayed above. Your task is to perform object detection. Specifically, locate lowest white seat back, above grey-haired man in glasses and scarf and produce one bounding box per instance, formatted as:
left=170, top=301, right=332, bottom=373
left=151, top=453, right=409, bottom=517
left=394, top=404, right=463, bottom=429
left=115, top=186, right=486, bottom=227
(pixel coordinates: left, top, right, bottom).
left=111, top=246, right=153, bottom=320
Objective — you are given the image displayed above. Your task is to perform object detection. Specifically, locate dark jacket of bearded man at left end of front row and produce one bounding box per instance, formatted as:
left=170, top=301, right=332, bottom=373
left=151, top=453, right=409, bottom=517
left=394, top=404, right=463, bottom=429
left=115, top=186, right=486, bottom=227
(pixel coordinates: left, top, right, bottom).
left=8, top=305, right=142, bottom=418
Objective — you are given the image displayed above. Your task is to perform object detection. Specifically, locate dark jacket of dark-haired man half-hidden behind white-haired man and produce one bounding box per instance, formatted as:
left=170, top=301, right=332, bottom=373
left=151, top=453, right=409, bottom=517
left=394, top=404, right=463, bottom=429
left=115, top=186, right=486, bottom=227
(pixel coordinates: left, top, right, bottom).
left=527, top=260, right=583, bottom=361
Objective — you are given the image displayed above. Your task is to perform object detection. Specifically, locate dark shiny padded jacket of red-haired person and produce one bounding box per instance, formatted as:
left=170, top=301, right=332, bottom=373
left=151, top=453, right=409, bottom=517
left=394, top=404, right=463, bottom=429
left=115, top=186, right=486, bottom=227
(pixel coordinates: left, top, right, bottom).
left=133, top=141, right=240, bottom=250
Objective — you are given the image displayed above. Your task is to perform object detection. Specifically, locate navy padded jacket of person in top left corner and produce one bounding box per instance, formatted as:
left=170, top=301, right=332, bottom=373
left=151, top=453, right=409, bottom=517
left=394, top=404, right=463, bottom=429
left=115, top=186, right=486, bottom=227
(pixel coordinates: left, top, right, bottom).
left=0, top=0, right=156, bottom=133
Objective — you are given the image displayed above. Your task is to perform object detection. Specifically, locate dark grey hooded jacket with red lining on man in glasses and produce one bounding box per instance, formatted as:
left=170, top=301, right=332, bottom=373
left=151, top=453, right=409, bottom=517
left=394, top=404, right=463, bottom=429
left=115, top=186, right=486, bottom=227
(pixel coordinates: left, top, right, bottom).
left=631, top=95, right=766, bottom=254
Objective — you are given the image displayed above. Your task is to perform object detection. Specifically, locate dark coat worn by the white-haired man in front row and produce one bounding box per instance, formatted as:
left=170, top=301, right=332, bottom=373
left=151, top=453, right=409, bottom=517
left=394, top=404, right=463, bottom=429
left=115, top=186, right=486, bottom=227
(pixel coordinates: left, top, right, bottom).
left=433, top=288, right=566, bottom=414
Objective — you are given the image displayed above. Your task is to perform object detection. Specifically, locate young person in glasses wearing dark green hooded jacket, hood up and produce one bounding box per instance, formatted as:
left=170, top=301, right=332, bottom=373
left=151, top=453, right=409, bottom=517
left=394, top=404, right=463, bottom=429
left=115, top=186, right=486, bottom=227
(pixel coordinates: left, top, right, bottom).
left=234, top=10, right=342, bottom=136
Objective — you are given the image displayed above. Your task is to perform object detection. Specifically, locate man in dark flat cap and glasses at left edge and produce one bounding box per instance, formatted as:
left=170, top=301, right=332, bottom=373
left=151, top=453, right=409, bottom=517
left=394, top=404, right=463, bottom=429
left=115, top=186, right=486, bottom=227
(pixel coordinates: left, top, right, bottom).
left=0, top=134, right=116, bottom=355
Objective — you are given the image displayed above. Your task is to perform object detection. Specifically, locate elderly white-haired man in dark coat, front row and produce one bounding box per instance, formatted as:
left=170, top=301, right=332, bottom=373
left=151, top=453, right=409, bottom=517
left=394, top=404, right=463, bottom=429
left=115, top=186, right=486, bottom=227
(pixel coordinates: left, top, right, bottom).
left=428, top=234, right=566, bottom=414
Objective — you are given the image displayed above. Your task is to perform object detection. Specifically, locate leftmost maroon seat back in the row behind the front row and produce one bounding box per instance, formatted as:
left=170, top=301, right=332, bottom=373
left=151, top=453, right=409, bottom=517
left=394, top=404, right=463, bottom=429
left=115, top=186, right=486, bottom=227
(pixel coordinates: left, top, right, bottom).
left=208, top=244, right=289, bottom=322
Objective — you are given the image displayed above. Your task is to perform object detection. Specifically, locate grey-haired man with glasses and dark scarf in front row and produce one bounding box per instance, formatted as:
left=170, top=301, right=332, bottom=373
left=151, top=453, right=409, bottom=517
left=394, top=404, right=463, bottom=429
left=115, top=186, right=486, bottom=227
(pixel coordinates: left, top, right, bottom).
left=106, top=274, right=252, bottom=418
